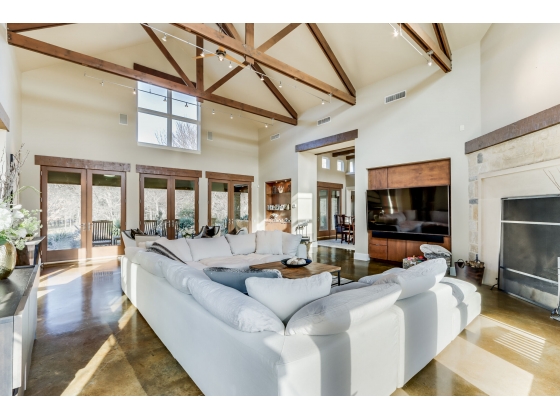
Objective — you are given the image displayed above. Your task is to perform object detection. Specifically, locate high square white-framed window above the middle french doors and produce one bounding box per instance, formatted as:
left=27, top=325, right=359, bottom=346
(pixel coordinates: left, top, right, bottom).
left=136, top=82, right=201, bottom=152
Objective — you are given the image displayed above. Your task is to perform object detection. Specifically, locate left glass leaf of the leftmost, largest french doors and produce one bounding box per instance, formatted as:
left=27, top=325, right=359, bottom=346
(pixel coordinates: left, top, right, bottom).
left=41, top=167, right=86, bottom=261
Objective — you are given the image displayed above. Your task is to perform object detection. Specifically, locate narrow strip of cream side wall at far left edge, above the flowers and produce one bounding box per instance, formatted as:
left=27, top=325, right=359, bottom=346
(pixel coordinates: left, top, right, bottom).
left=0, top=23, right=21, bottom=163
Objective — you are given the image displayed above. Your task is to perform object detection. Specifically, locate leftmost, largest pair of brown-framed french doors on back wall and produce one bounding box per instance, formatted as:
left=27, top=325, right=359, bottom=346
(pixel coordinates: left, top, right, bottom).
left=41, top=166, right=126, bottom=262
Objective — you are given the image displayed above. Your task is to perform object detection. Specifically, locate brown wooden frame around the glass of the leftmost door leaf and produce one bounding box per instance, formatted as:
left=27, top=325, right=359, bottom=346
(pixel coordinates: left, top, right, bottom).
left=40, top=165, right=88, bottom=263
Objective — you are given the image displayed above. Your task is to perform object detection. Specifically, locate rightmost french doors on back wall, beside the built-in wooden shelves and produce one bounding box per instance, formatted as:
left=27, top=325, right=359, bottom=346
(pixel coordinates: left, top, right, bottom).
left=208, top=179, right=252, bottom=234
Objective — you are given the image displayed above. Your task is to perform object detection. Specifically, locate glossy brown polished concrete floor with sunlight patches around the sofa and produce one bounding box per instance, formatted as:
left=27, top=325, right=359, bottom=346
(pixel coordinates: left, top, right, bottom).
left=26, top=247, right=560, bottom=395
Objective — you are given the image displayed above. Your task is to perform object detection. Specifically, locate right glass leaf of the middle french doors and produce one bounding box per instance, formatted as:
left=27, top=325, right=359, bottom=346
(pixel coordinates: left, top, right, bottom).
left=175, top=179, right=198, bottom=238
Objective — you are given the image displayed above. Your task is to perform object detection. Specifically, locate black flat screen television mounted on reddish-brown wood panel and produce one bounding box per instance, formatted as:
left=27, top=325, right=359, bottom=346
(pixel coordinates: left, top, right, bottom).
left=367, top=185, right=449, bottom=237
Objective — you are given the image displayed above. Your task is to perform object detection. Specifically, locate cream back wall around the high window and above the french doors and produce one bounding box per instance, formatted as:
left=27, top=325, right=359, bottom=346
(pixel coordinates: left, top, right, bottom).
left=22, top=43, right=258, bottom=229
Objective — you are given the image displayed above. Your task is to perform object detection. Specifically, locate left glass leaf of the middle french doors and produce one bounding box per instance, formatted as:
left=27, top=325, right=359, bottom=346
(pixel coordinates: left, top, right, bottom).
left=141, top=177, right=168, bottom=236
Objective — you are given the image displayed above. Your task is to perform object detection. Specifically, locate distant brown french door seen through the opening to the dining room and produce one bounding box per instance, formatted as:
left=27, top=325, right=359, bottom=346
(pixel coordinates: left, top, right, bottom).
left=317, top=183, right=342, bottom=238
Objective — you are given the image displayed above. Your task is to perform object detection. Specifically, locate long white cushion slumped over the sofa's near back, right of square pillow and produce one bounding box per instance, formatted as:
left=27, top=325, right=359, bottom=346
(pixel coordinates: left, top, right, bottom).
left=286, top=283, right=401, bottom=335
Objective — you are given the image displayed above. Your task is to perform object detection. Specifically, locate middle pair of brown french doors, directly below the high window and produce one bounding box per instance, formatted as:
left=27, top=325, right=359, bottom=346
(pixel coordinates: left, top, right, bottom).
left=140, top=174, right=198, bottom=239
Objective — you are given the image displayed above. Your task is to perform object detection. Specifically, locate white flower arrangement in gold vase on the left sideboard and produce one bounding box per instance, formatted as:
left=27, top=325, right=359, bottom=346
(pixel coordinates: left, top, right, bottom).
left=0, top=147, right=41, bottom=280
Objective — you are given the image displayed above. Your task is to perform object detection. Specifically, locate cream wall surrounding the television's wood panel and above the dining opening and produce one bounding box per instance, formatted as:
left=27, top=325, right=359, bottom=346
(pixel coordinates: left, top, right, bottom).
left=259, top=43, right=480, bottom=259
